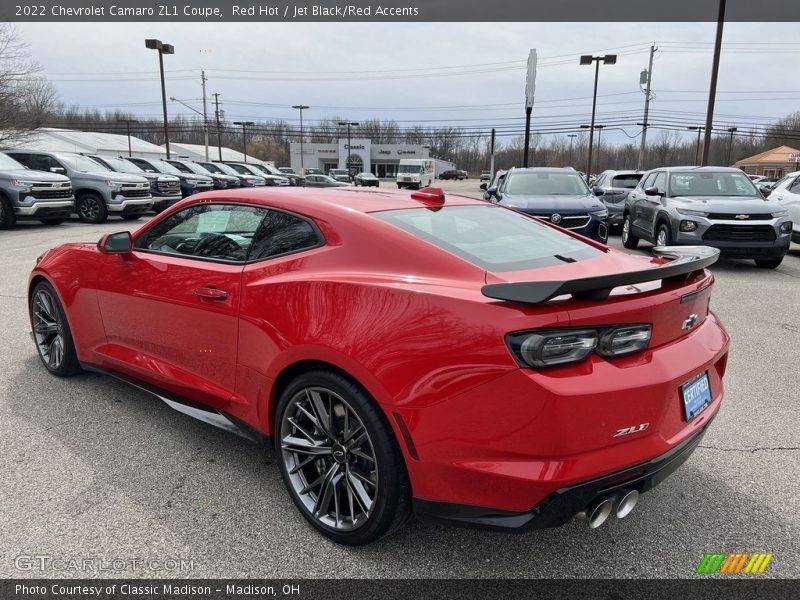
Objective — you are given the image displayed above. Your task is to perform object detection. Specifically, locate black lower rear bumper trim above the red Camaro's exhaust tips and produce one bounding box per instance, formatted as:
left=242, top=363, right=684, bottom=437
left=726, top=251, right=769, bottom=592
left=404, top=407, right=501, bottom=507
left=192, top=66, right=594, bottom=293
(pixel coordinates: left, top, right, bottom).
left=413, top=415, right=714, bottom=531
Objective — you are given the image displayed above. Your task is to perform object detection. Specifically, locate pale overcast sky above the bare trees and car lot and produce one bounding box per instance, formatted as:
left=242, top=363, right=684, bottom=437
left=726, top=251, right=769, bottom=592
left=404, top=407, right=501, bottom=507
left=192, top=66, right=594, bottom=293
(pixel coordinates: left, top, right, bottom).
left=19, top=23, right=800, bottom=147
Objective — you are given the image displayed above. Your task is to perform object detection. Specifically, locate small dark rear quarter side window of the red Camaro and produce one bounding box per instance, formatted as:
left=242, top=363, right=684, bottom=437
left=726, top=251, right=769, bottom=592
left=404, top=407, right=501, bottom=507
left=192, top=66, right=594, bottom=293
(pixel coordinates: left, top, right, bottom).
left=248, top=209, right=324, bottom=260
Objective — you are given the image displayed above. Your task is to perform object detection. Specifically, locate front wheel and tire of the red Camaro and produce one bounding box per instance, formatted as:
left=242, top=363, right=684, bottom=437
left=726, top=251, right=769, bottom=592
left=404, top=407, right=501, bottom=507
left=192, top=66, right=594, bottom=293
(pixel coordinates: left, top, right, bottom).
left=29, top=281, right=81, bottom=377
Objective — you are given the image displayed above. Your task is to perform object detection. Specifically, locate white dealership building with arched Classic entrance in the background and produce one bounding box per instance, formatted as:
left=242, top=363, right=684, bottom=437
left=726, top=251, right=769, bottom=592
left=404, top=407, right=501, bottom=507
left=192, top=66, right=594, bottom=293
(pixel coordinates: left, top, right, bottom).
left=289, top=138, right=455, bottom=178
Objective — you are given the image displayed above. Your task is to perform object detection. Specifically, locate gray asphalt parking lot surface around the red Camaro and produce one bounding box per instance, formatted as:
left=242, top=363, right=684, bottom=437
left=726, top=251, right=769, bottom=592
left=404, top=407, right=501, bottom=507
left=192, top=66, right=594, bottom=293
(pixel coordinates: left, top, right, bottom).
left=0, top=180, right=800, bottom=578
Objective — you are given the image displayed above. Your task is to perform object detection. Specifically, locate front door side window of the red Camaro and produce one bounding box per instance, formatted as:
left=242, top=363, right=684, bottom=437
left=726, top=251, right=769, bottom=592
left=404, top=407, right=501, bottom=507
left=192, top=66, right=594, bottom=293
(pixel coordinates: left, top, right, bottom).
left=136, top=204, right=267, bottom=262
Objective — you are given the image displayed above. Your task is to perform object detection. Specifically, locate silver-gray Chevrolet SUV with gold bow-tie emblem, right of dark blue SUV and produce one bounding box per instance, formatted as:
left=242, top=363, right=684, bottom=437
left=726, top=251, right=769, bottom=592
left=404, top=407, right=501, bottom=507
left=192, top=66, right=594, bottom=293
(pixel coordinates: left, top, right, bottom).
left=622, top=167, right=792, bottom=269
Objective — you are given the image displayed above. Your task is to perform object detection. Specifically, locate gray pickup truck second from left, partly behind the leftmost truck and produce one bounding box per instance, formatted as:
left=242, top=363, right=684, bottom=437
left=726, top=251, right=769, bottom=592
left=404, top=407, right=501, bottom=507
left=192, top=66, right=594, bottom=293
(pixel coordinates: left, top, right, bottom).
left=6, top=150, right=153, bottom=223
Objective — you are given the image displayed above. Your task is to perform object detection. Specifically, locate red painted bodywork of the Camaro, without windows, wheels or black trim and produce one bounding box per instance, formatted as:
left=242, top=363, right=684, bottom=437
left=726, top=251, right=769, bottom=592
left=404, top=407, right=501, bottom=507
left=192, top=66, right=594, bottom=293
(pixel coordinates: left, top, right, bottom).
left=31, top=188, right=729, bottom=524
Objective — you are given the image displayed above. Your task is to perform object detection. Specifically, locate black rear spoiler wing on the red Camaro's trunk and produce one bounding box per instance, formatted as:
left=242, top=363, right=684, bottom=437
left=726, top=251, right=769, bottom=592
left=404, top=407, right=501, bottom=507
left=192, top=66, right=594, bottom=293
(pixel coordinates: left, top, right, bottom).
left=481, top=246, right=719, bottom=304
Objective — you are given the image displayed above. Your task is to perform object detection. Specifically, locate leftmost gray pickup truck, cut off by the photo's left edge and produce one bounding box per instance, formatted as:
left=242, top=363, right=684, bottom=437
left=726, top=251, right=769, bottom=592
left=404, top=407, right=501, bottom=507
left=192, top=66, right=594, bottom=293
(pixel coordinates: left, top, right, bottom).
left=0, top=152, right=75, bottom=229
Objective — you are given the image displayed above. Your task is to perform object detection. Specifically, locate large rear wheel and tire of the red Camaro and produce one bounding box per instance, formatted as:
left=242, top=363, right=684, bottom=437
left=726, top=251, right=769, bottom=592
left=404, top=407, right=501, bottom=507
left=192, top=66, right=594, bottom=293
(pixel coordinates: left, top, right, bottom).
left=275, top=369, right=411, bottom=546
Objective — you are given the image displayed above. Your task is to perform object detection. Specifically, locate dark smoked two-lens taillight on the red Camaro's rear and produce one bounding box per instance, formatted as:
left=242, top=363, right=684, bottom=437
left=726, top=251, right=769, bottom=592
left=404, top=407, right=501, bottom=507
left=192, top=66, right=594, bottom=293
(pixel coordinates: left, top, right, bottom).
left=506, top=324, right=652, bottom=368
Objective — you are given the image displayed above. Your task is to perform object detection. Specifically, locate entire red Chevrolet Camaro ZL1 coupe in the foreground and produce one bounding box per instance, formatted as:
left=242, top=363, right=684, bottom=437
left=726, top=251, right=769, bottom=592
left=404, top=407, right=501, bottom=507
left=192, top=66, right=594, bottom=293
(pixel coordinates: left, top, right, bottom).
left=29, top=188, right=729, bottom=544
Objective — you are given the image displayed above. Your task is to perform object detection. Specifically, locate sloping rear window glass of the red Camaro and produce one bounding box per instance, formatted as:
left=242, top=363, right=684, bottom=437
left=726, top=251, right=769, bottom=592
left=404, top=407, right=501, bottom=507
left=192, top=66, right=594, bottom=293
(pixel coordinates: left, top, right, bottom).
left=373, top=206, right=602, bottom=271
